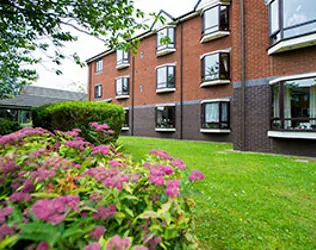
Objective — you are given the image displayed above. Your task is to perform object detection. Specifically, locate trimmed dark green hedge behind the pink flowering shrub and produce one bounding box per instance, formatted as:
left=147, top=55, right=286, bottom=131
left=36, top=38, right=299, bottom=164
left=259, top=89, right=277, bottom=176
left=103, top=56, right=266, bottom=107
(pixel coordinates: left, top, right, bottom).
left=32, top=101, right=125, bottom=144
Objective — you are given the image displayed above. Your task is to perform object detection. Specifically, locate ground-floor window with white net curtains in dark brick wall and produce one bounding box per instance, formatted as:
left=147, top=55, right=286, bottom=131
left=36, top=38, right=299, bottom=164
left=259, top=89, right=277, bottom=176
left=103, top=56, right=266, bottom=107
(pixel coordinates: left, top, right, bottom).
left=201, top=101, right=230, bottom=129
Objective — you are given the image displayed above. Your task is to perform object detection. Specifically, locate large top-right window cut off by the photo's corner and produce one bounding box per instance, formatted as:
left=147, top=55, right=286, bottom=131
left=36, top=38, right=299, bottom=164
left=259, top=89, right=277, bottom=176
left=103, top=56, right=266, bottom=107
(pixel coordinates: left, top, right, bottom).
left=269, top=0, right=316, bottom=45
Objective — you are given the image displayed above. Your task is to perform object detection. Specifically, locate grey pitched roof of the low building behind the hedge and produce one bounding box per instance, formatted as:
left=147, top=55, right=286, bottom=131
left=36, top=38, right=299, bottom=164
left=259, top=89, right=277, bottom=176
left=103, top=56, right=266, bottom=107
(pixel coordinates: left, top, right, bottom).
left=0, top=86, right=88, bottom=107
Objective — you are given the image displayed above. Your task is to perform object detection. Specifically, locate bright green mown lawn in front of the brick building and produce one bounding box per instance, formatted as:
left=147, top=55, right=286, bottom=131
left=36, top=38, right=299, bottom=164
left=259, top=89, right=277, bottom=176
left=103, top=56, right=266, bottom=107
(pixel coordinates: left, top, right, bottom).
left=119, top=137, right=316, bottom=250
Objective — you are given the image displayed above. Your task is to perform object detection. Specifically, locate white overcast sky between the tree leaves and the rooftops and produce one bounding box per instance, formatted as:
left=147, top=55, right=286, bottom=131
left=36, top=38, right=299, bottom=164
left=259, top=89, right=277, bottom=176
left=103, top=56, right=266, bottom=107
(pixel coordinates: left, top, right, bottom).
left=33, top=0, right=197, bottom=91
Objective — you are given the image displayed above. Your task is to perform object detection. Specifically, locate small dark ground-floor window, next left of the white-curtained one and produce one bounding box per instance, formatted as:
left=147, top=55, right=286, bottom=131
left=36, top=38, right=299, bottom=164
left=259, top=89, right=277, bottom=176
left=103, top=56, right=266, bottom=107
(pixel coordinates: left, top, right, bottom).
left=156, top=106, right=176, bottom=129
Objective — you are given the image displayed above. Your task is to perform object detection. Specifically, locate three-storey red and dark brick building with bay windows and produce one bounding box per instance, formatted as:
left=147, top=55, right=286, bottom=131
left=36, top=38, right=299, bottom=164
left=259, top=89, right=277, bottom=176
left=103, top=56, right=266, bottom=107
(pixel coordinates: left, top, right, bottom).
left=87, top=0, right=316, bottom=156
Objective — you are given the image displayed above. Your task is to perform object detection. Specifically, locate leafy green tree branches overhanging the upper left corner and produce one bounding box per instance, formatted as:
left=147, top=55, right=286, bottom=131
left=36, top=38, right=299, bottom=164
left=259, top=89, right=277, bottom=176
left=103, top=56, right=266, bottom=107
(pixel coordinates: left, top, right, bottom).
left=0, top=0, right=147, bottom=98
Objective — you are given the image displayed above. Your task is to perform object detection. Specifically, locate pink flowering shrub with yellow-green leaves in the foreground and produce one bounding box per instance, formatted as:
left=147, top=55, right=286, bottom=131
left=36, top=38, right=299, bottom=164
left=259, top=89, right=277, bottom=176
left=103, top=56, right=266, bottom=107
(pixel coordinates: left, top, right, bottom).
left=0, top=126, right=205, bottom=250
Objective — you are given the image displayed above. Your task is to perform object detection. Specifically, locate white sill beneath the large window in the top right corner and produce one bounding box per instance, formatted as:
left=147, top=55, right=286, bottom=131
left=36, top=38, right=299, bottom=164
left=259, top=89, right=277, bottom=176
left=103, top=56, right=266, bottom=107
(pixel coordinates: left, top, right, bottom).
left=268, top=33, right=316, bottom=55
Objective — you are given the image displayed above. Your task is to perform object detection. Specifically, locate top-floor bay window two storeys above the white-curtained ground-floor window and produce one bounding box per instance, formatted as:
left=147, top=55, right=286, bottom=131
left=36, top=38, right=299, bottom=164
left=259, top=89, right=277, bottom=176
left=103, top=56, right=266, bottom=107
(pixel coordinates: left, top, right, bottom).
left=201, top=5, right=229, bottom=42
